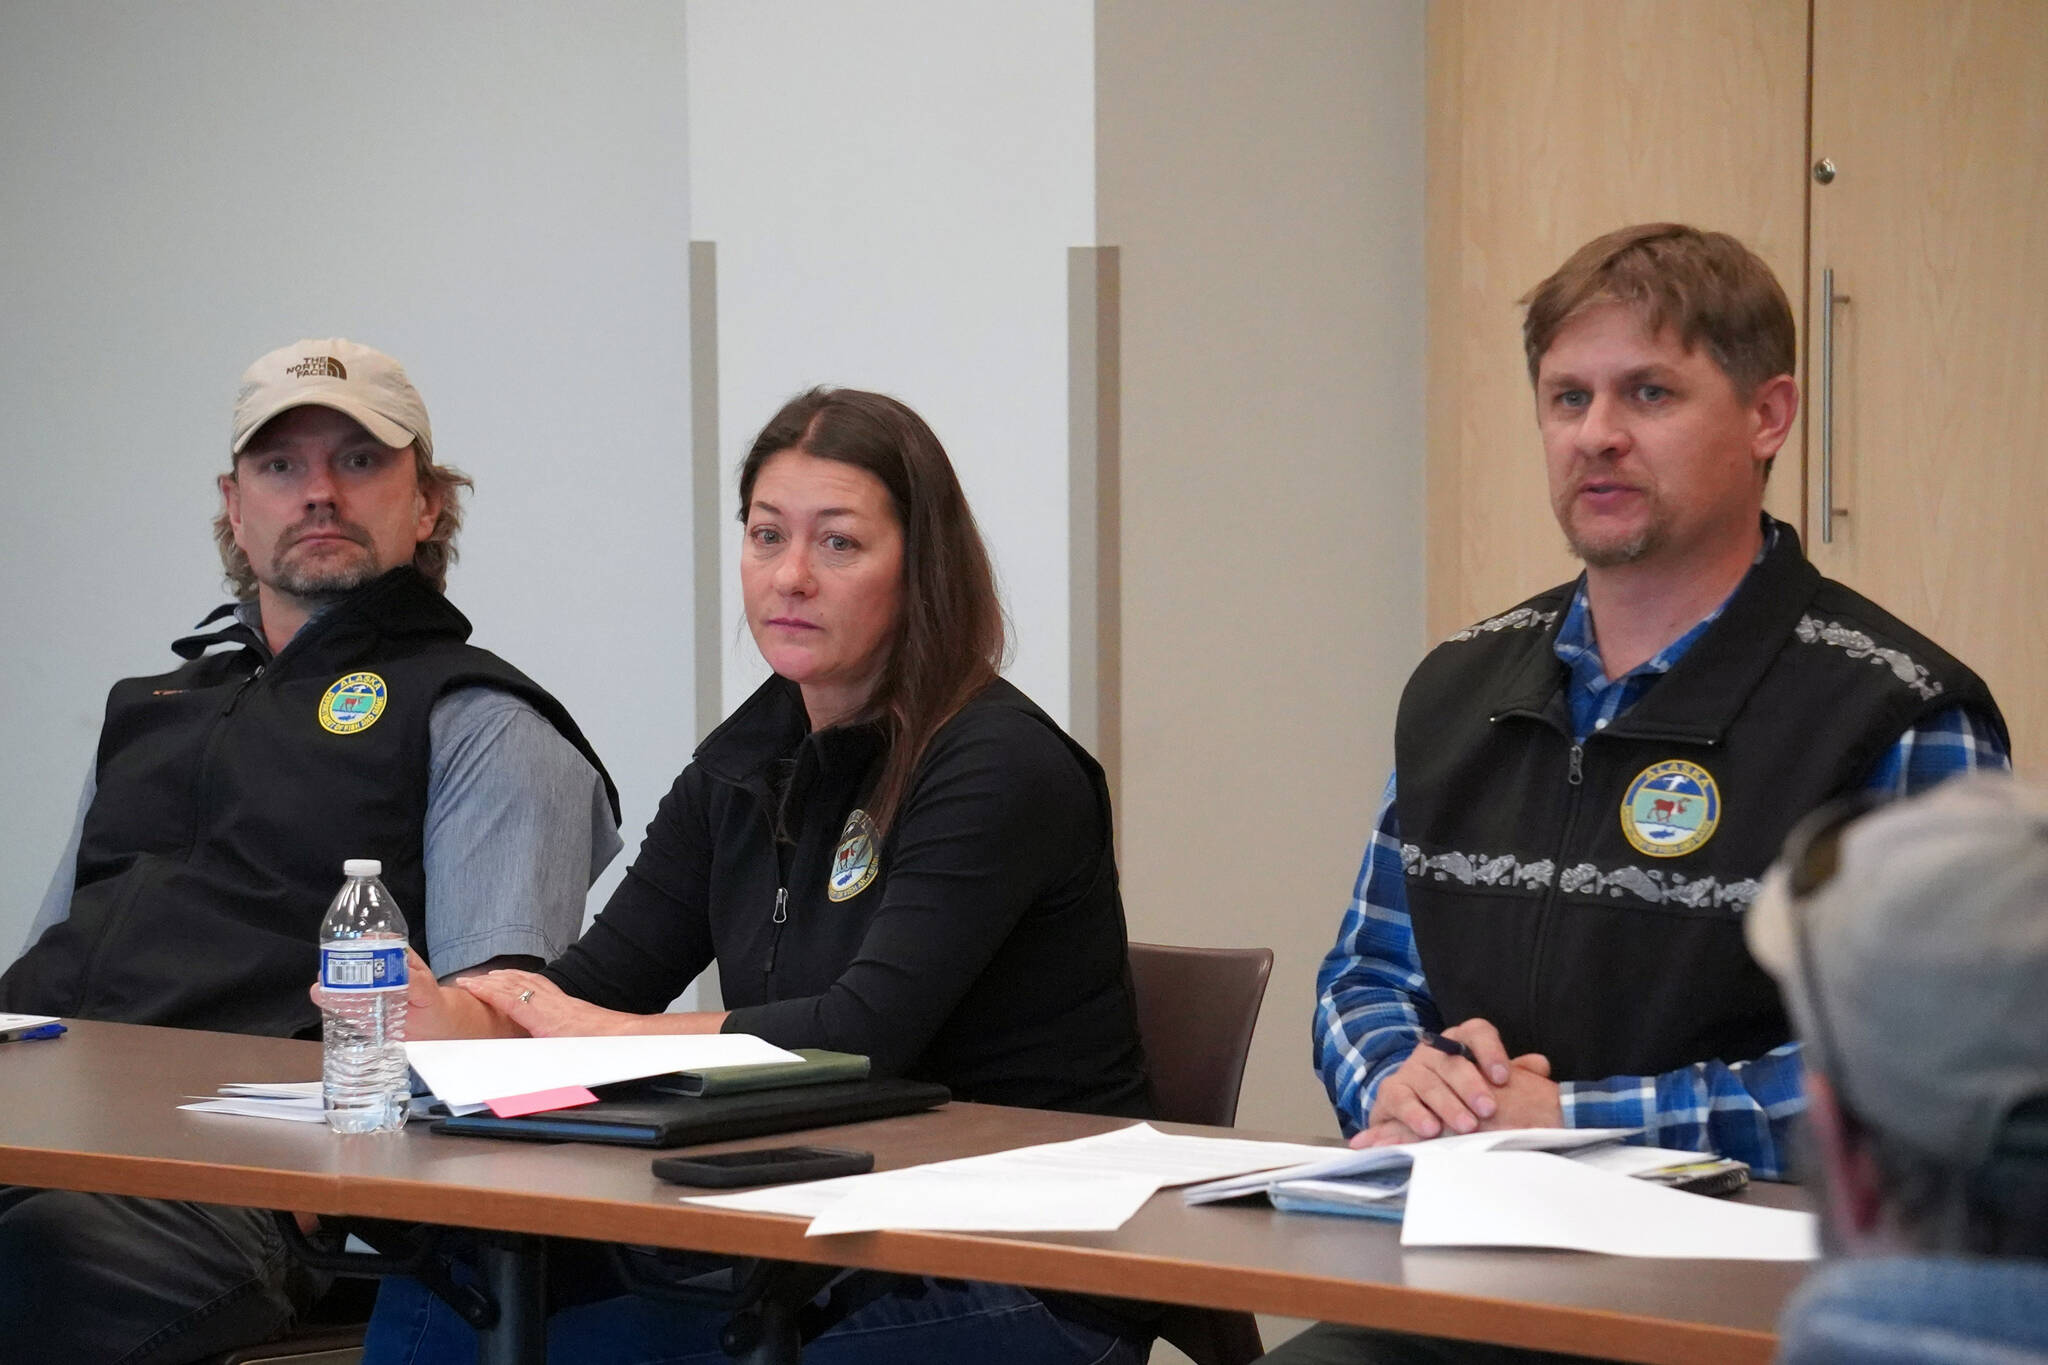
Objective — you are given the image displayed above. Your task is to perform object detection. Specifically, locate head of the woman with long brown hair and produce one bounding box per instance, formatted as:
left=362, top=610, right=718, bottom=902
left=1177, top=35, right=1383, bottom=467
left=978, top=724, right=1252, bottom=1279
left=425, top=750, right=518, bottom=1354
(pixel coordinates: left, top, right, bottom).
left=739, top=389, right=1004, bottom=829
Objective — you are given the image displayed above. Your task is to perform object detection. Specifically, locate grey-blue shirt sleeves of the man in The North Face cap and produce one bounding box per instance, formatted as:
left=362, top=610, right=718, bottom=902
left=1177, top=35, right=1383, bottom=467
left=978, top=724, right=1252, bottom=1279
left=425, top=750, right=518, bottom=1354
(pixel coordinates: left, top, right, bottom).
left=29, top=688, right=623, bottom=978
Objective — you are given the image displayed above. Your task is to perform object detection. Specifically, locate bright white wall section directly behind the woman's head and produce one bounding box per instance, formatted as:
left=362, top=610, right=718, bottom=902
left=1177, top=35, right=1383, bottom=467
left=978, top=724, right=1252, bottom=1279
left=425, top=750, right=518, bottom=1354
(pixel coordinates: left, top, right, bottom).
left=688, top=0, right=1096, bottom=720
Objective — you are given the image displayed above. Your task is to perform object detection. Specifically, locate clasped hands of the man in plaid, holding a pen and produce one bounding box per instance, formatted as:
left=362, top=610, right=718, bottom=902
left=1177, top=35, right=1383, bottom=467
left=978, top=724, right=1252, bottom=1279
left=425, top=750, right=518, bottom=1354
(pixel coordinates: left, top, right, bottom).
left=1352, top=1019, right=1565, bottom=1146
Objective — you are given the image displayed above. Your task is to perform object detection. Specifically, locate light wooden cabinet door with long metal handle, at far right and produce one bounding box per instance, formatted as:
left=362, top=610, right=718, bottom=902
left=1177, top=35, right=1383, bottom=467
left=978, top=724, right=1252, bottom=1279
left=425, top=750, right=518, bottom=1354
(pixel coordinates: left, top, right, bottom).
left=1806, top=0, right=2048, bottom=767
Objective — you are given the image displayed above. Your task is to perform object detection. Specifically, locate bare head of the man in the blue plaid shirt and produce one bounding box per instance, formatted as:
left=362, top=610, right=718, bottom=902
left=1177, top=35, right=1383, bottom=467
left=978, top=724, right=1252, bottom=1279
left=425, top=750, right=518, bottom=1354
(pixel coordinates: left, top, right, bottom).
left=1522, top=223, right=1798, bottom=569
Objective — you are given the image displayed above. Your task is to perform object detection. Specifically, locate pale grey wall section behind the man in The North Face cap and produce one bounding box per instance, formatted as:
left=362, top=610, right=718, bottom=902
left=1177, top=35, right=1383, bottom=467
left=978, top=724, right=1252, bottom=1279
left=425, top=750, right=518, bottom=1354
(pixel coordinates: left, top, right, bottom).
left=0, top=0, right=694, bottom=962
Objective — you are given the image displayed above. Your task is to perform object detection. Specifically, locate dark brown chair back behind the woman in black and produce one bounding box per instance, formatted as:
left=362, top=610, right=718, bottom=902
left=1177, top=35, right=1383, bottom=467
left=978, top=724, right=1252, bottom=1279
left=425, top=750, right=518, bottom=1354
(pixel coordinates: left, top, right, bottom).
left=1130, top=943, right=1274, bottom=1128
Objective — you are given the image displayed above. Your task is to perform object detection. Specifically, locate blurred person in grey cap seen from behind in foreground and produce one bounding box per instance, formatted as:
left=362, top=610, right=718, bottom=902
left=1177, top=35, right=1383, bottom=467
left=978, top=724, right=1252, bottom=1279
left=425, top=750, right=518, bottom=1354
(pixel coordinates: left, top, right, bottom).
left=1745, top=776, right=2048, bottom=1365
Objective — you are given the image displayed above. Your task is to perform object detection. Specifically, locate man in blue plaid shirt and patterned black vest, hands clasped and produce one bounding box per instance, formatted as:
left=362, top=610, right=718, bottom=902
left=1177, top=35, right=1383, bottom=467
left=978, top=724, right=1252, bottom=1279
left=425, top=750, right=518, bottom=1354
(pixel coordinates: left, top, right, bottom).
left=1276, top=223, right=2007, bottom=1363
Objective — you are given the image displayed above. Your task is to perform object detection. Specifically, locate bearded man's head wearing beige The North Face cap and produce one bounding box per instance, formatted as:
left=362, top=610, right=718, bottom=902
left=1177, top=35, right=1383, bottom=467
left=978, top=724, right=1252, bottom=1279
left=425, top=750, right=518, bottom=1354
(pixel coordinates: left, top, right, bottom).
left=213, top=338, right=471, bottom=620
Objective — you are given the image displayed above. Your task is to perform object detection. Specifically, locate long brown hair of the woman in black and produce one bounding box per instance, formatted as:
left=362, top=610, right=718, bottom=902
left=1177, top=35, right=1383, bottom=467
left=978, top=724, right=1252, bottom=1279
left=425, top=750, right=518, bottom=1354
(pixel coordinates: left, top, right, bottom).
left=739, top=389, right=1004, bottom=831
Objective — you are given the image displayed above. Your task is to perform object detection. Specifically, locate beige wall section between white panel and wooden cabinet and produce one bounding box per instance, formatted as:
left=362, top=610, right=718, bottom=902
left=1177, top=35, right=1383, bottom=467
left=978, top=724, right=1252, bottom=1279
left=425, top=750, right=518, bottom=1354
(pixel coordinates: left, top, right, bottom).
left=1096, top=0, right=1423, bottom=1132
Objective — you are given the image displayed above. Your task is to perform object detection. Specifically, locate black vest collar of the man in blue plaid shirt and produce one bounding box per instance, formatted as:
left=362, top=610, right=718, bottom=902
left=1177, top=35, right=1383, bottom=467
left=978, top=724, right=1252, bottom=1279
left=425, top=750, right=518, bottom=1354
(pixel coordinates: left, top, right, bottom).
left=1489, top=522, right=1821, bottom=745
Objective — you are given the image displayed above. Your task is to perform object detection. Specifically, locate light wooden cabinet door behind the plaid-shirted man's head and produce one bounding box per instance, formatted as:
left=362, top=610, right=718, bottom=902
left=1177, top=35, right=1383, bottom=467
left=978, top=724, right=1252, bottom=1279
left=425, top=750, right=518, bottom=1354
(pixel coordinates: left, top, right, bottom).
left=1425, top=0, right=1806, bottom=639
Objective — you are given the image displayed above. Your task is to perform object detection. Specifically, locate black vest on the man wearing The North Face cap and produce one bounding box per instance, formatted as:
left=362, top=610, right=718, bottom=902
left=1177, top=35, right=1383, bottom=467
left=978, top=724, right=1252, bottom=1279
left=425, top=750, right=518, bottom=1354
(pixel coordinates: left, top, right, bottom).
left=0, top=567, right=618, bottom=1036
